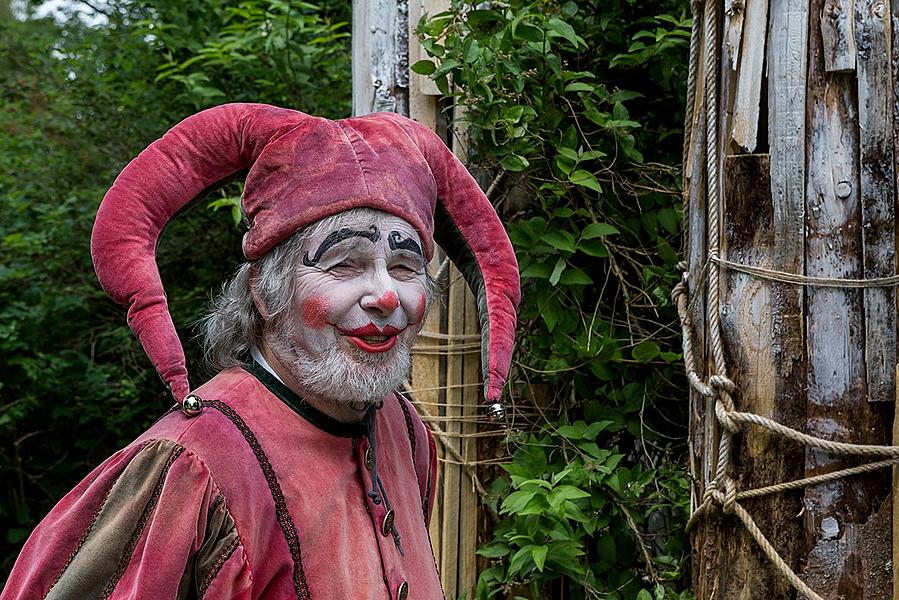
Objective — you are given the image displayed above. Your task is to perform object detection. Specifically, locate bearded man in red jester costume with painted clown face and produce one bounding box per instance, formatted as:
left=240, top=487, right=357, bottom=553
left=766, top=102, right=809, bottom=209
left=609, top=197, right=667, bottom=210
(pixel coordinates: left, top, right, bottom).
left=0, top=104, right=519, bottom=600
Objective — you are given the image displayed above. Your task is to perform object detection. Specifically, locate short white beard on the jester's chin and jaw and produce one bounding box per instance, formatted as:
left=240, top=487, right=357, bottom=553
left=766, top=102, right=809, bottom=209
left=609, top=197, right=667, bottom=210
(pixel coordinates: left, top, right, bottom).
left=272, top=332, right=413, bottom=410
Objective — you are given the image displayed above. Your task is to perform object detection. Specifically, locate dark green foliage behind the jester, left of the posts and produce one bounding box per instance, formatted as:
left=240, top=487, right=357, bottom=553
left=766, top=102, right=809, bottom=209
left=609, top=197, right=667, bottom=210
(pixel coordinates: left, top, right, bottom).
left=0, top=0, right=350, bottom=579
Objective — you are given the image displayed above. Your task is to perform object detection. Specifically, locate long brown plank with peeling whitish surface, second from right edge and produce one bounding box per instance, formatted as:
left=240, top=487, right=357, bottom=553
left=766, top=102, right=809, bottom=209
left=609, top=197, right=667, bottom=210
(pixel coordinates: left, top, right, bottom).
left=802, top=0, right=892, bottom=598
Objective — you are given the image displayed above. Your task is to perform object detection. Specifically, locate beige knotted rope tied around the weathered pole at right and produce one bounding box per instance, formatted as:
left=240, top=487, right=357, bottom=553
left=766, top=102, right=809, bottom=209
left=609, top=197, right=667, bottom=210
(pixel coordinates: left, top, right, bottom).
left=672, top=0, right=899, bottom=600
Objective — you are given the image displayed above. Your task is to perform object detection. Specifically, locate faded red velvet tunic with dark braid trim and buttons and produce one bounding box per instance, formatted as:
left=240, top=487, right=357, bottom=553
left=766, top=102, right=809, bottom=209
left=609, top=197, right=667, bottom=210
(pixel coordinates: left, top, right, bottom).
left=0, top=366, right=443, bottom=600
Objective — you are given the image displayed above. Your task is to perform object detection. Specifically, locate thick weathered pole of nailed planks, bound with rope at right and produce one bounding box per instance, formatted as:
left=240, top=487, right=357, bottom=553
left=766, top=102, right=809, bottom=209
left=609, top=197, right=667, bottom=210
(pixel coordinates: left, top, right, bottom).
left=684, top=0, right=899, bottom=600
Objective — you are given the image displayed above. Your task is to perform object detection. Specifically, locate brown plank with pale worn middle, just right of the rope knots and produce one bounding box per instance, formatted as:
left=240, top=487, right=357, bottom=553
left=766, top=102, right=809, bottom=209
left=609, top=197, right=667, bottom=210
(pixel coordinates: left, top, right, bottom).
left=719, top=154, right=805, bottom=600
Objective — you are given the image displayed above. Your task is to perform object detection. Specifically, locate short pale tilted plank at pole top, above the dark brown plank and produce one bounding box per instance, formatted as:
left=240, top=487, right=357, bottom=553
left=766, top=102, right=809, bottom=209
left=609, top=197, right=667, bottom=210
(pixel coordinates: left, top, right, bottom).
left=731, top=0, right=768, bottom=153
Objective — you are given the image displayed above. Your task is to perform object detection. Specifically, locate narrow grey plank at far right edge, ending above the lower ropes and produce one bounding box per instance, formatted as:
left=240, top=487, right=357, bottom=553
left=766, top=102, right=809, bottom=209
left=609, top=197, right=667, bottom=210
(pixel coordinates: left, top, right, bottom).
left=856, top=0, right=896, bottom=402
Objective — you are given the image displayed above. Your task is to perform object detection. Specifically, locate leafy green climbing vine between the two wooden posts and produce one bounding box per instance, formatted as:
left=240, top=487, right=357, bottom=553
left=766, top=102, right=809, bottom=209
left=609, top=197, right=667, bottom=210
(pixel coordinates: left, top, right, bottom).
left=412, top=0, right=690, bottom=600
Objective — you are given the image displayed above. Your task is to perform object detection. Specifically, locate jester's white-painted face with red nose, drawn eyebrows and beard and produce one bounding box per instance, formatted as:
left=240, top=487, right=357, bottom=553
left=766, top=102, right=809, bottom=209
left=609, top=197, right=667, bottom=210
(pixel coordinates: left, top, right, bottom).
left=264, top=211, right=428, bottom=405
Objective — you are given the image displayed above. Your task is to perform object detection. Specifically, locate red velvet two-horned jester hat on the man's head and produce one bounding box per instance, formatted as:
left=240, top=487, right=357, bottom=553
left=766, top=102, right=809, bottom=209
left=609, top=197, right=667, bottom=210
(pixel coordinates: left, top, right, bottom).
left=91, top=104, right=520, bottom=403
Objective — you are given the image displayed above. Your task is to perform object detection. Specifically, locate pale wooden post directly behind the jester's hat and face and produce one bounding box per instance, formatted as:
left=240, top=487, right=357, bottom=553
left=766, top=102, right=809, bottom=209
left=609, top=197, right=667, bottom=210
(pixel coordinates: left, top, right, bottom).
left=353, top=0, right=481, bottom=598
